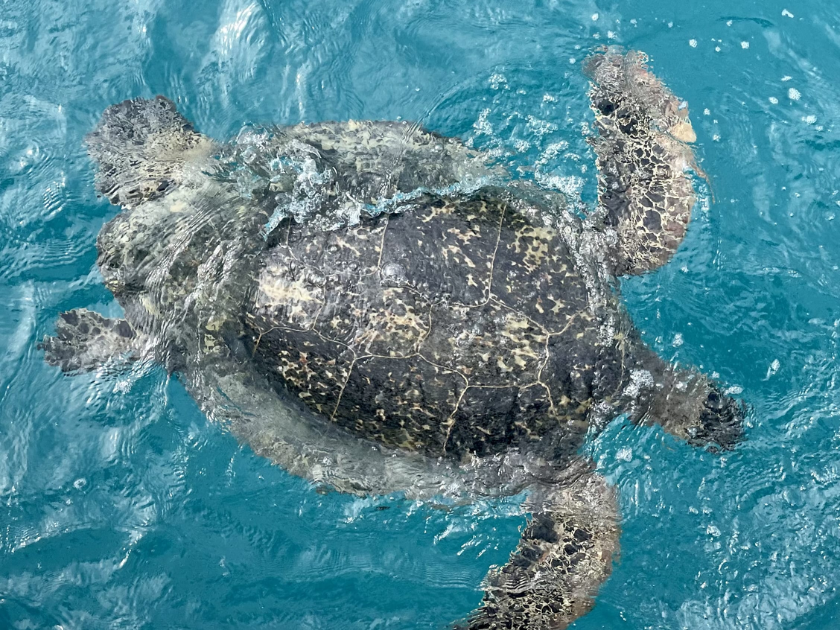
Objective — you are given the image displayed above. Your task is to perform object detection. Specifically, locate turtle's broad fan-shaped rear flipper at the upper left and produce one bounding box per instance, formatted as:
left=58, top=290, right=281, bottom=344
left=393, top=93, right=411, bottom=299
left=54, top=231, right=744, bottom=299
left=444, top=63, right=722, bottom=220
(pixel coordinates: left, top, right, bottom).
left=85, top=96, right=212, bottom=209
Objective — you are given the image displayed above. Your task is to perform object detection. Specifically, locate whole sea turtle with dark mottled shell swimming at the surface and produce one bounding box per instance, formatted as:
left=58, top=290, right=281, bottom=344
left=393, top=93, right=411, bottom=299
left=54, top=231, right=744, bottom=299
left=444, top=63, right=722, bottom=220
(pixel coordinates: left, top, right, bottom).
left=42, top=49, right=743, bottom=629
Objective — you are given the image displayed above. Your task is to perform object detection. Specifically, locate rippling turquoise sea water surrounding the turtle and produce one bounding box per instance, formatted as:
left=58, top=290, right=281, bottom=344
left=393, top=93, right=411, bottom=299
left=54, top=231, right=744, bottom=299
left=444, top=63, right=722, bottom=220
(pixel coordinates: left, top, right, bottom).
left=0, top=0, right=840, bottom=630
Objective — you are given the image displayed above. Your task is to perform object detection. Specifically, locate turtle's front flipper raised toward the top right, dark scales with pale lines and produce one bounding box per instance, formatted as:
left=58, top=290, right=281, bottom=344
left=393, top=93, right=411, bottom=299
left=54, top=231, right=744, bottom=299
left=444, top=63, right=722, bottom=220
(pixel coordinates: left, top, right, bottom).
left=587, top=49, right=703, bottom=275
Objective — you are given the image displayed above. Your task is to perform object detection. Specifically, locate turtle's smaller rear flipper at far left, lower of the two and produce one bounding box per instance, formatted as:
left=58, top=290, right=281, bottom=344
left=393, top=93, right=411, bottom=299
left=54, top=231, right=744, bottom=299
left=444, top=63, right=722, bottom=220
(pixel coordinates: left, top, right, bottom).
left=38, top=308, right=138, bottom=372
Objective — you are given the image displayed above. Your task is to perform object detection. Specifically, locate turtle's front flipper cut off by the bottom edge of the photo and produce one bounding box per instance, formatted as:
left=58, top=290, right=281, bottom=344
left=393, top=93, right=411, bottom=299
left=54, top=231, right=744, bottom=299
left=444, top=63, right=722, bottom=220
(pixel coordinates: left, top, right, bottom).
left=457, top=473, right=620, bottom=630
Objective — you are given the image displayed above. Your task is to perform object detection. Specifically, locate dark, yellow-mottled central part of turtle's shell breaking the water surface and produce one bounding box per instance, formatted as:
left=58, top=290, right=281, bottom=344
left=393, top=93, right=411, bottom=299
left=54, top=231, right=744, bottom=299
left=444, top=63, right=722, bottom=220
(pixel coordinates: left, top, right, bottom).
left=245, top=189, right=621, bottom=457
